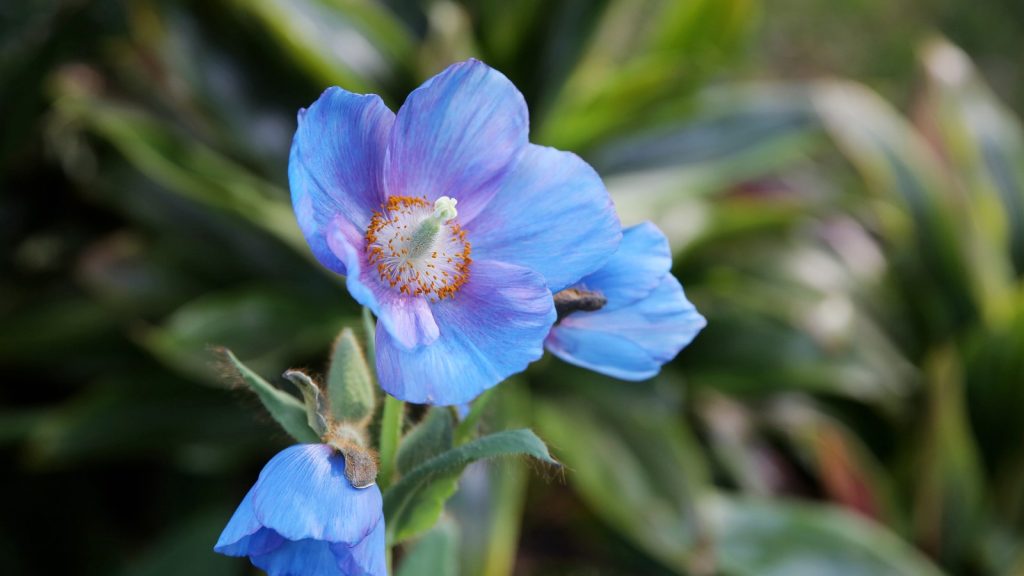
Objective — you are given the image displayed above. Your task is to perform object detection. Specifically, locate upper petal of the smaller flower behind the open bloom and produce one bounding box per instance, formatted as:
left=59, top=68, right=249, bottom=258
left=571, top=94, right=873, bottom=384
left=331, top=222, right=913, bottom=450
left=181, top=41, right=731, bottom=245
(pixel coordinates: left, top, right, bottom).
left=578, top=222, right=672, bottom=312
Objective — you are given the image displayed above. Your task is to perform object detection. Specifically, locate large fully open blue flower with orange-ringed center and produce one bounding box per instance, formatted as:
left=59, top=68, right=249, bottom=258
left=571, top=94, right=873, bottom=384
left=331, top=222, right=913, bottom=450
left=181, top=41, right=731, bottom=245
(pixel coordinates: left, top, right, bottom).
left=289, top=60, right=622, bottom=405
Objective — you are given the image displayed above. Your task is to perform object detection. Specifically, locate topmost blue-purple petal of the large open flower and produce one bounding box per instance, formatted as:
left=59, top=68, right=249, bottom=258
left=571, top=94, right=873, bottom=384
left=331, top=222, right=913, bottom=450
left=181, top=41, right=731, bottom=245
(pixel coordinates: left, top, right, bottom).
left=384, top=59, right=529, bottom=224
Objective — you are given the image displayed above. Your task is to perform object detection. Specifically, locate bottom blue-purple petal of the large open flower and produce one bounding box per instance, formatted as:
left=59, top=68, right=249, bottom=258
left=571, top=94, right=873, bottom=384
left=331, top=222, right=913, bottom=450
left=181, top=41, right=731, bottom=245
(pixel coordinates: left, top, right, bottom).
left=377, top=260, right=555, bottom=405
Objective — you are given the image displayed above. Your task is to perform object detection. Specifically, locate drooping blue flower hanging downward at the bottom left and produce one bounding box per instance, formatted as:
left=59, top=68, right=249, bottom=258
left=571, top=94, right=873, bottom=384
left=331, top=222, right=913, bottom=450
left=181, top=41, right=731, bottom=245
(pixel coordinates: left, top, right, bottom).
left=214, top=444, right=386, bottom=576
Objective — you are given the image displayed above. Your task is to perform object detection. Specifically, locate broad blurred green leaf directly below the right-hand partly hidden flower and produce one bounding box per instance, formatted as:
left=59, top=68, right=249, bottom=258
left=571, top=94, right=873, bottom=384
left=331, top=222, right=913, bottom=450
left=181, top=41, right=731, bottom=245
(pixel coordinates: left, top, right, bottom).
left=534, top=381, right=708, bottom=572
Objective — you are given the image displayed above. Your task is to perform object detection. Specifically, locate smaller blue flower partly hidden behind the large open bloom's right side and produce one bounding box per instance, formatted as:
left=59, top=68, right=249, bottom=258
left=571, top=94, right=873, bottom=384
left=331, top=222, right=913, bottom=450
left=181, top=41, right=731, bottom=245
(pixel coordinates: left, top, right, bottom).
left=545, top=222, right=707, bottom=380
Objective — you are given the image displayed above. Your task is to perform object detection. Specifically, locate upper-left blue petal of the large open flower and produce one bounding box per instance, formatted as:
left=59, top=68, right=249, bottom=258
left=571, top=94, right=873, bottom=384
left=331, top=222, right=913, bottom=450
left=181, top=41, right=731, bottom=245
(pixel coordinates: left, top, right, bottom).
left=288, top=87, right=394, bottom=274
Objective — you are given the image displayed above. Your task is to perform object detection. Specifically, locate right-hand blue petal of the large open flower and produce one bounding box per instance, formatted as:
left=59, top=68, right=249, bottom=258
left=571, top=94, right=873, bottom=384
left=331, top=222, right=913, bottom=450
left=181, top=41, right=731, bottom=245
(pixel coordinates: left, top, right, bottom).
left=467, top=145, right=622, bottom=292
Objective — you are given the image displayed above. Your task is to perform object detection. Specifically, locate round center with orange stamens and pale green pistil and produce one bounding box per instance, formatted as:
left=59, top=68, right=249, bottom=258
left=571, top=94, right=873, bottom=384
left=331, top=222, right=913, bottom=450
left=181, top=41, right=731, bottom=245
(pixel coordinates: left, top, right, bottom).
left=366, top=196, right=472, bottom=301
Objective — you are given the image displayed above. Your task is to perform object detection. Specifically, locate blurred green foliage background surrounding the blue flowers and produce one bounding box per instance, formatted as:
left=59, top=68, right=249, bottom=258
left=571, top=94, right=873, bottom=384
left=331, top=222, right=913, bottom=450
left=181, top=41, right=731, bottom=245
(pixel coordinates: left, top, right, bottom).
left=0, top=0, right=1024, bottom=576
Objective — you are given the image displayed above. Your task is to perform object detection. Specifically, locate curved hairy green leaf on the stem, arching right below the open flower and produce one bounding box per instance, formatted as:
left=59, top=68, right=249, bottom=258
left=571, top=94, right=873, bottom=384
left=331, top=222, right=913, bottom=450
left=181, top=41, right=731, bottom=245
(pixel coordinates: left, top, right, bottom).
left=384, top=428, right=558, bottom=542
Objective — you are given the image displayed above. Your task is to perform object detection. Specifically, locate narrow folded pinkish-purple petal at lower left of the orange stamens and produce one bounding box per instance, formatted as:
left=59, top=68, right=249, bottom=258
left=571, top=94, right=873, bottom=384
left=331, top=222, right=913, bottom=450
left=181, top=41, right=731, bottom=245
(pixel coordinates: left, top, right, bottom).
left=328, top=218, right=438, bottom=348
